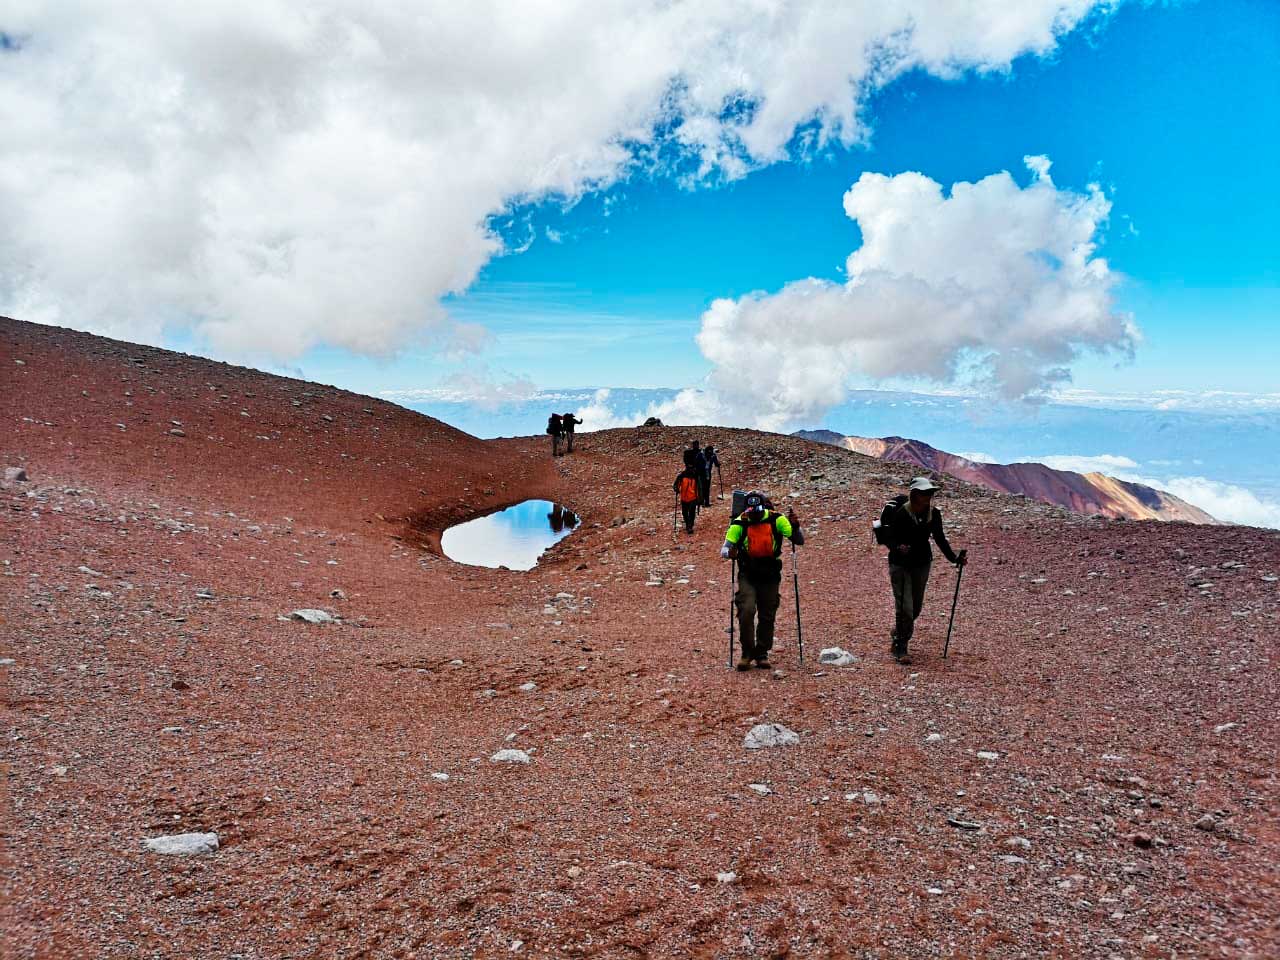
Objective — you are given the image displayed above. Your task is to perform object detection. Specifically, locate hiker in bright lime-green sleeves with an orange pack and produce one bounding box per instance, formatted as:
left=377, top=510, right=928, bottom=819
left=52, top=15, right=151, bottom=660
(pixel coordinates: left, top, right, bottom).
left=721, top=490, right=804, bottom=669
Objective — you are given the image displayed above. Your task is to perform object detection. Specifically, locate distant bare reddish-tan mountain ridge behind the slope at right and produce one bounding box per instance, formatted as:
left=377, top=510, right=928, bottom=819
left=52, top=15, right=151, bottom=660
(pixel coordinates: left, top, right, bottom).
left=796, top=430, right=1219, bottom=524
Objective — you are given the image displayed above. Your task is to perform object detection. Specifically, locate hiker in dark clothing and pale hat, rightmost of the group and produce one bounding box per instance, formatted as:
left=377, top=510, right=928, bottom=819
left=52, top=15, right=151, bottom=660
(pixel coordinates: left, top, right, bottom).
left=882, top=476, right=968, bottom=663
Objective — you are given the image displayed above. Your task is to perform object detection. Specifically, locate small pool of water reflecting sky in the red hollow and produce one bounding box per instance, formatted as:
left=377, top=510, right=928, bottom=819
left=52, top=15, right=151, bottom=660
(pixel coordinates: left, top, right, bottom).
left=440, top=500, right=582, bottom=570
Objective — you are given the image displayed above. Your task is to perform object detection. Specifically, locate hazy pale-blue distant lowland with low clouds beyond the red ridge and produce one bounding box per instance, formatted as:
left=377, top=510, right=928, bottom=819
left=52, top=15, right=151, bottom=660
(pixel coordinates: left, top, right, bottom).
left=387, top=388, right=1280, bottom=529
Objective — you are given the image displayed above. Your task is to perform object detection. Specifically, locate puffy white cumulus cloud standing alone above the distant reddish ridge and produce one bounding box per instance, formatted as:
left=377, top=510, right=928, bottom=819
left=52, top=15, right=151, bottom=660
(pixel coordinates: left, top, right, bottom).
left=691, top=157, right=1138, bottom=430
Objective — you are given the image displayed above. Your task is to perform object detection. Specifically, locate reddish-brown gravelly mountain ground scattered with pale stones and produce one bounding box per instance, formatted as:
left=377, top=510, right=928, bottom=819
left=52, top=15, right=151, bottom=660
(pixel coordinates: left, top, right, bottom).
left=0, top=320, right=1280, bottom=959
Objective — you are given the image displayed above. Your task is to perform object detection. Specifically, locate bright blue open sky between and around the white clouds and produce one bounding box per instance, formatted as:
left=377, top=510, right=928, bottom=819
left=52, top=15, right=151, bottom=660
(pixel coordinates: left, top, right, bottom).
left=300, top=0, right=1280, bottom=393
